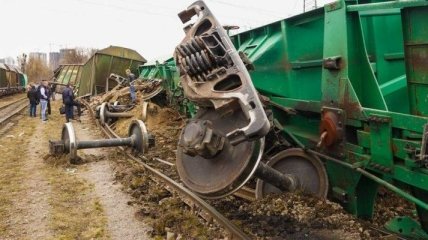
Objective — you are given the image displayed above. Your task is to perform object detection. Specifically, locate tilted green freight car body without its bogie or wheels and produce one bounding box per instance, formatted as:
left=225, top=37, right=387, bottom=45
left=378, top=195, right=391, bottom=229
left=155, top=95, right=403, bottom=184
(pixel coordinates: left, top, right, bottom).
left=227, top=0, right=428, bottom=236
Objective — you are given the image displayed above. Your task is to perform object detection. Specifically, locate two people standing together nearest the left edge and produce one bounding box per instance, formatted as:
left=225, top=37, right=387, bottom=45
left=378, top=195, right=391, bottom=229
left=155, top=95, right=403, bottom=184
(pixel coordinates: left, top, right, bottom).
left=27, top=80, right=55, bottom=122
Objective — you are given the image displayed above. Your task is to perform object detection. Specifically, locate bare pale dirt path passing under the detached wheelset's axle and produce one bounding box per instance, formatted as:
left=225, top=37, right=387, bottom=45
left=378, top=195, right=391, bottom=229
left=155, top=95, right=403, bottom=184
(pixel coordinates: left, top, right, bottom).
left=74, top=116, right=150, bottom=239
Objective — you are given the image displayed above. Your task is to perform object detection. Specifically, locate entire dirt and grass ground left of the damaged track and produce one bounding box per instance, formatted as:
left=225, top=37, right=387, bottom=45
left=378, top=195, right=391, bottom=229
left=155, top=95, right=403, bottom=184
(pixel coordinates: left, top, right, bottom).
left=0, top=98, right=151, bottom=239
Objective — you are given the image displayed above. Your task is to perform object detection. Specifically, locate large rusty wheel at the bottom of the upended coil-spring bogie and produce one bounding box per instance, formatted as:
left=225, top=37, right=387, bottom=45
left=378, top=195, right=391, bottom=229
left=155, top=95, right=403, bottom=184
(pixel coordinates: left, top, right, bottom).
left=176, top=109, right=264, bottom=199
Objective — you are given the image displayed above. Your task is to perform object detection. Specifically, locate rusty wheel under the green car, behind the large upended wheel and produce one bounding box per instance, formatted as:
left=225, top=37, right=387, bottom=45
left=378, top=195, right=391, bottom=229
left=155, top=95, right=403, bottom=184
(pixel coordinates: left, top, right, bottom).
left=256, top=148, right=328, bottom=199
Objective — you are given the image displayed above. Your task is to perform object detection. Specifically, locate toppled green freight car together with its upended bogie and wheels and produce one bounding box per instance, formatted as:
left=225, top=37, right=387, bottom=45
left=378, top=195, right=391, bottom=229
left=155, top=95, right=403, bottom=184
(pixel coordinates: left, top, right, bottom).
left=141, top=0, right=428, bottom=239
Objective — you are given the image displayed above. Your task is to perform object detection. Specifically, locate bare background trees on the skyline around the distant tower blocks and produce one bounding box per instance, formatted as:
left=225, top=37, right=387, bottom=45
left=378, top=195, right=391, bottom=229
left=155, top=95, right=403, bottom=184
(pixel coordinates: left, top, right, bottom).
left=18, top=48, right=97, bottom=82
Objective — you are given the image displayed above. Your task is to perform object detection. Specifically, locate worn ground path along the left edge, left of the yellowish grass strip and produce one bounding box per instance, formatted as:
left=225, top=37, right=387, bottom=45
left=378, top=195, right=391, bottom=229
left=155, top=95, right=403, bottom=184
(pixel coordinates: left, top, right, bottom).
left=0, top=118, right=52, bottom=239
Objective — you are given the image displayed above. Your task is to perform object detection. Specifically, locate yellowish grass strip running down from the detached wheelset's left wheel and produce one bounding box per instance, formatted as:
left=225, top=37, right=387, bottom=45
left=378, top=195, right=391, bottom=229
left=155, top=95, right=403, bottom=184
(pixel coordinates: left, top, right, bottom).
left=43, top=101, right=110, bottom=239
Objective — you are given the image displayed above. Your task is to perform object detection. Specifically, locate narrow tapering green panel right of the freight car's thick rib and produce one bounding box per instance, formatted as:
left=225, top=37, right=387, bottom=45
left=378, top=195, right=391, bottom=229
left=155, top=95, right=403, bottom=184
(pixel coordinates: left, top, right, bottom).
left=360, top=10, right=409, bottom=113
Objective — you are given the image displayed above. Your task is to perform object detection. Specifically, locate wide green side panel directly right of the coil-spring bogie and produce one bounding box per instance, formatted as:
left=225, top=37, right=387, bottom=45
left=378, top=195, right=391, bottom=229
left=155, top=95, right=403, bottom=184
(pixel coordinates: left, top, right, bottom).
left=231, top=9, right=324, bottom=101
